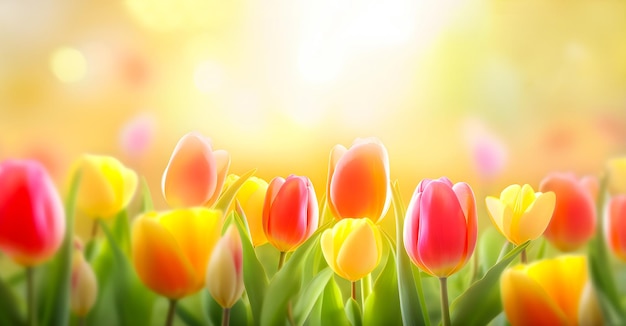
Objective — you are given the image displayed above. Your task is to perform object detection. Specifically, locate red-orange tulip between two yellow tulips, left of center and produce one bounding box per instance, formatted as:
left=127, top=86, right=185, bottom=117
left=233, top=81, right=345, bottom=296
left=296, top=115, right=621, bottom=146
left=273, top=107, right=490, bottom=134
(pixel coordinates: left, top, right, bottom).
left=263, top=175, right=319, bottom=252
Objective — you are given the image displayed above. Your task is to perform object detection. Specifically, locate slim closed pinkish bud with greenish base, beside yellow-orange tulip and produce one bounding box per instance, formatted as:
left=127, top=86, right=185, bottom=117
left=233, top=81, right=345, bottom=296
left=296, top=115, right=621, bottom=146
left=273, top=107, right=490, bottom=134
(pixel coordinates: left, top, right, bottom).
left=206, top=225, right=244, bottom=308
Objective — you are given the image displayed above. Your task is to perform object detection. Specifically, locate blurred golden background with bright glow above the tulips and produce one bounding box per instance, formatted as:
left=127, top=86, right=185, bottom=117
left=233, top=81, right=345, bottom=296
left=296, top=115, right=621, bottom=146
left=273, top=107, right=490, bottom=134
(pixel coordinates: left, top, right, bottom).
left=0, top=0, right=626, bottom=219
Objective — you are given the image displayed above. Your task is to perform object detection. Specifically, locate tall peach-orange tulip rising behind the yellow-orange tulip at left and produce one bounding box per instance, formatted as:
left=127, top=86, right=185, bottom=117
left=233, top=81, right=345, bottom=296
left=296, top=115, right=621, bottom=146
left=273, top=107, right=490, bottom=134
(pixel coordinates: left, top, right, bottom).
left=161, top=132, right=230, bottom=208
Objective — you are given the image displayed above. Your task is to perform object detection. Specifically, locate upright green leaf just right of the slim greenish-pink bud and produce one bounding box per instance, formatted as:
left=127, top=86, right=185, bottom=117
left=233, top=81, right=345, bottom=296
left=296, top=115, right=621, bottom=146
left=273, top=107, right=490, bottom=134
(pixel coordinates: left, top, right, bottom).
left=230, top=210, right=268, bottom=321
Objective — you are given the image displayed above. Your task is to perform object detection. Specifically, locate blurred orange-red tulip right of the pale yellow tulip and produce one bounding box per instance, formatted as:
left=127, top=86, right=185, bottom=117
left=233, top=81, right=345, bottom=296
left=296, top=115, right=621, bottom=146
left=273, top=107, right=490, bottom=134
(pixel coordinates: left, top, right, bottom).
left=539, top=174, right=596, bottom=251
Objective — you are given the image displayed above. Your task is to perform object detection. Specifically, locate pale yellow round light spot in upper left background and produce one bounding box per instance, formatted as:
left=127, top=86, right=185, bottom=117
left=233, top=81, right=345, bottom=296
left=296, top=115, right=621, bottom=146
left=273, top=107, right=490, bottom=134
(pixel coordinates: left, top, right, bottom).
left=50, top=47, right=87, bottom=83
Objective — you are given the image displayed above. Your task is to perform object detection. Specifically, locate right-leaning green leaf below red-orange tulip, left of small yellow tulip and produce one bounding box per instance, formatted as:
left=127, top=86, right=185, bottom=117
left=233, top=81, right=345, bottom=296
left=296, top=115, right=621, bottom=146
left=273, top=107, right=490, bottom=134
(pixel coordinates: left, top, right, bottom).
left=261, top=233, right=321, bottom=325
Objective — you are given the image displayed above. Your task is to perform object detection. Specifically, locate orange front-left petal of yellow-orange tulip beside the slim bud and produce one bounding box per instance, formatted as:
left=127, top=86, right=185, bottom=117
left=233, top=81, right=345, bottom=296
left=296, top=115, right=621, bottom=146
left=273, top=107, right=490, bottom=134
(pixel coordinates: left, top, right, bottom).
left=132, top=213, right=198, bottom=299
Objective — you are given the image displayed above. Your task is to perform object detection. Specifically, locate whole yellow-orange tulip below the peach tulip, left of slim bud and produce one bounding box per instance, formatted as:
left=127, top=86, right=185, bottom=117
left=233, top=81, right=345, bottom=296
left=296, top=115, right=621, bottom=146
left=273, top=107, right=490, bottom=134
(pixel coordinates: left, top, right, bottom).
left=132, top=207, right=222, bottom=299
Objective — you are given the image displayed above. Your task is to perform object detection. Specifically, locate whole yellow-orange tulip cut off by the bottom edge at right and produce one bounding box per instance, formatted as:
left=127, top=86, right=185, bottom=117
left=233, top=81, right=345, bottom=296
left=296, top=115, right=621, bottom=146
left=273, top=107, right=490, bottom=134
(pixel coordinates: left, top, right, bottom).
left=500, top=256, right=588, bottom=326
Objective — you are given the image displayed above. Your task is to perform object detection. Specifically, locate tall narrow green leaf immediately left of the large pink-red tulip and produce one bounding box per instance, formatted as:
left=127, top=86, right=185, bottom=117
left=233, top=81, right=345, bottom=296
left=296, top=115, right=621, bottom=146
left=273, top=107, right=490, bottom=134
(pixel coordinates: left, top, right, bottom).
left=392, top=181, right=430, bottom=325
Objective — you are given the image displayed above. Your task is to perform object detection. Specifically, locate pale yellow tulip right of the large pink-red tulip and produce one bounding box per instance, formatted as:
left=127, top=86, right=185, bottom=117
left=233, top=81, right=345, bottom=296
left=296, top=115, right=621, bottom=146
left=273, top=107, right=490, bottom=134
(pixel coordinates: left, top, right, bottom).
left=485, top=184, right=556, bottom=245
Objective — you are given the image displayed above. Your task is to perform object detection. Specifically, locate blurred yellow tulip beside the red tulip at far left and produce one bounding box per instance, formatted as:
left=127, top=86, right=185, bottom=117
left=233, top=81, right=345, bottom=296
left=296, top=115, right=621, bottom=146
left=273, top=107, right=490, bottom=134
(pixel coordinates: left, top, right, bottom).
left=75, top=154, right=137, bottom=218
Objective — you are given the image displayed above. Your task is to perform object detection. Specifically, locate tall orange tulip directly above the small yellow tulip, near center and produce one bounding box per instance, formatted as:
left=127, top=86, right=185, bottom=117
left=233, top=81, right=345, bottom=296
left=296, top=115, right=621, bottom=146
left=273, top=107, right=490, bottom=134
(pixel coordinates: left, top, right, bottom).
left=326, top=138, right=391, bottom=223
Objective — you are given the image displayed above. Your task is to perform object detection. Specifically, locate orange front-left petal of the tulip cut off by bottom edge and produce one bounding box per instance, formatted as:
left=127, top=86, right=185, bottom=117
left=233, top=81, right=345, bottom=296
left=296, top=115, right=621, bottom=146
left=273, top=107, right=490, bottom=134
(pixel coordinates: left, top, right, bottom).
left=500, top=268, right=568, bottom=326
